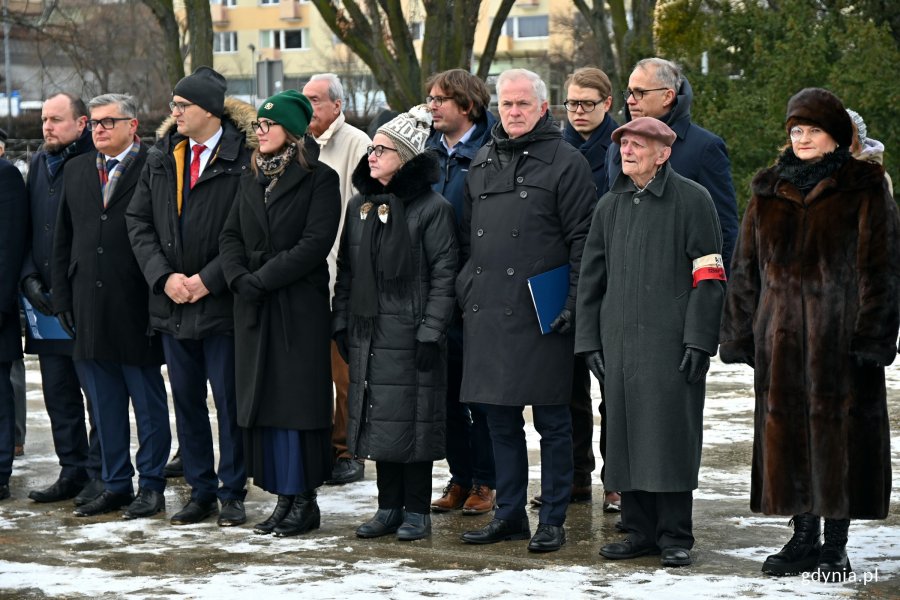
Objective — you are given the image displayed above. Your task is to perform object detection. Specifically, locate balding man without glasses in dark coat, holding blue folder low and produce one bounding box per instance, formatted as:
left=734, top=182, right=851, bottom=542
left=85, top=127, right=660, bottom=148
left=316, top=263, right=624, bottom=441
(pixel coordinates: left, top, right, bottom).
left=20, top=93, right=103, bottom=506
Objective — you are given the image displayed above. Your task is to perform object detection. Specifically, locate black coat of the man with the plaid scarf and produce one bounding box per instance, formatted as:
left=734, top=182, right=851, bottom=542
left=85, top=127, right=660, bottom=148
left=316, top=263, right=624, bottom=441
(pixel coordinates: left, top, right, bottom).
left=52, top=145, right=163, bottom=366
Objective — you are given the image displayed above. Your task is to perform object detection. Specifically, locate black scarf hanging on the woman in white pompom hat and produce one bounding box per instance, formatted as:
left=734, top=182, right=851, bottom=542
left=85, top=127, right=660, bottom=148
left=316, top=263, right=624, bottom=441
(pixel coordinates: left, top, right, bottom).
left=349, top=193, right=415, bottom=337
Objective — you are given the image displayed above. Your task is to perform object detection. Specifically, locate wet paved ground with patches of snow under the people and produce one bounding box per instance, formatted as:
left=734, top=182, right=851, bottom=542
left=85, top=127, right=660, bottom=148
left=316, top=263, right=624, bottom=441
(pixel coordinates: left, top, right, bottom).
left=0, top=361, right=900, bottom=599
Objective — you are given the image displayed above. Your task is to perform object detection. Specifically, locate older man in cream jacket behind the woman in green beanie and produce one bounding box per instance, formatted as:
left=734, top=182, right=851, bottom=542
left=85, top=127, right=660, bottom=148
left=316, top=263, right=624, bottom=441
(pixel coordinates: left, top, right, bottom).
left=303, top=73, right=371, bottom=485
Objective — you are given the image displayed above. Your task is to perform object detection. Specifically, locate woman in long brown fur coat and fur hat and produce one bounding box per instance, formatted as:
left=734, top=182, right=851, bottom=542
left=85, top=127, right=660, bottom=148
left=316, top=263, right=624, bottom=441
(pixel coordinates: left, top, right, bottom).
left=719, top=88, right=900, bottom=581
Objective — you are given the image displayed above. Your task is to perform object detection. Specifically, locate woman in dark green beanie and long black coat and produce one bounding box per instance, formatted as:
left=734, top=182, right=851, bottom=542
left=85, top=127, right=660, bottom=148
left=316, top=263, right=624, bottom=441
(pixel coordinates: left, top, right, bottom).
left=220, top=90, right=341, bottom=536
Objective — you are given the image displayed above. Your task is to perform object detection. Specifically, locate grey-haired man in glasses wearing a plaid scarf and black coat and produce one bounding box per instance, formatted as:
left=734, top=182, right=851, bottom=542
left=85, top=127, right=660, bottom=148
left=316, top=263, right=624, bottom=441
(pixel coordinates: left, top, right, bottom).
left=52, top=94, right=171, bottom=519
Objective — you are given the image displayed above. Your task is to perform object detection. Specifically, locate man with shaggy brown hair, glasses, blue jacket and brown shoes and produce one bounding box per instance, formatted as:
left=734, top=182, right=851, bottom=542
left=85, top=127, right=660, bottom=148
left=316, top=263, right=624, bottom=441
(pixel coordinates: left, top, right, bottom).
left=425, top=69, right=497, bottom=515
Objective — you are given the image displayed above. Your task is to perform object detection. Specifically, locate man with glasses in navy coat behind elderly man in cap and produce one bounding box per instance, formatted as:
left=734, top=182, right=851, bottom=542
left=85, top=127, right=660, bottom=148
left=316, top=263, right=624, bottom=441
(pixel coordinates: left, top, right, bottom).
left=604, top=58, right=738, bottom=273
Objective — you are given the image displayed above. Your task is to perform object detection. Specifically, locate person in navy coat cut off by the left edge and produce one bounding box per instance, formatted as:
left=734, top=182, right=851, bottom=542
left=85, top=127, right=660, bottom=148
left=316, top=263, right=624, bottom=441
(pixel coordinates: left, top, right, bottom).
left=0, top=158, right=28, bottom=500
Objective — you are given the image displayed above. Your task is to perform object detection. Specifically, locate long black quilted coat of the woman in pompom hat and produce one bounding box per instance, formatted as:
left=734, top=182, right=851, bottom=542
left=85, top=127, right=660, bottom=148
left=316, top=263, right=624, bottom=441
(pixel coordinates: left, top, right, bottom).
left=332, top=153, right=458, bottom=463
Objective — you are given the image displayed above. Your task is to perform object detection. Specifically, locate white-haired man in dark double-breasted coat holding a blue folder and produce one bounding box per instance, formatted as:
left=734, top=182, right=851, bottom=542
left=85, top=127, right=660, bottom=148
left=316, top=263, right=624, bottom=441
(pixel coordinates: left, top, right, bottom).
left=456, top=69, right=597, bottom=552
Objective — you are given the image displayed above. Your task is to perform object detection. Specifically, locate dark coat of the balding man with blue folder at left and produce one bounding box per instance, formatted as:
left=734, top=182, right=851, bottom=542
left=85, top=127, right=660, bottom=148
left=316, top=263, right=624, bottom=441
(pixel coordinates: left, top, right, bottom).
left=21, top=129, right=94, bottom=356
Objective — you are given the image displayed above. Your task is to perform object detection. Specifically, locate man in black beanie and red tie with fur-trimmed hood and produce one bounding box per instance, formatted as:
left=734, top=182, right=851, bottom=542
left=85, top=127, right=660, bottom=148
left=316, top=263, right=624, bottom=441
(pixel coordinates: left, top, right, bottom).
left=127, top=67, right=255, bottom=527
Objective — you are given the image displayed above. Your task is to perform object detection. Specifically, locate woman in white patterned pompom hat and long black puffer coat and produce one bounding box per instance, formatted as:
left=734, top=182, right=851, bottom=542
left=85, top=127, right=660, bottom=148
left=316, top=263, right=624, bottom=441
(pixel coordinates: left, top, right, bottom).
left=333, top=106, right=458, bottom=540
